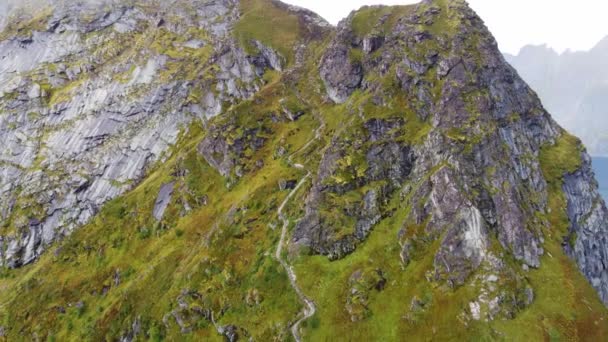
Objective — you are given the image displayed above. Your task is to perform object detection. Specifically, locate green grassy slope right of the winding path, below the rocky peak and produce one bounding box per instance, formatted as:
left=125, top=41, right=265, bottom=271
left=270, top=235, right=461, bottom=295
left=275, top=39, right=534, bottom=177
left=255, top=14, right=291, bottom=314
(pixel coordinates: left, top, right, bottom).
left=294, top=1, right=608, bottom=341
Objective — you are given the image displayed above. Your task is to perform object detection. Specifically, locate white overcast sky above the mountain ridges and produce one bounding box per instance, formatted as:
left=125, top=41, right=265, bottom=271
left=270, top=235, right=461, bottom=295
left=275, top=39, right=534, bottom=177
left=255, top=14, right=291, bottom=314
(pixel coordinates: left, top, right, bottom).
left=284, top=0, right=608, bottom=53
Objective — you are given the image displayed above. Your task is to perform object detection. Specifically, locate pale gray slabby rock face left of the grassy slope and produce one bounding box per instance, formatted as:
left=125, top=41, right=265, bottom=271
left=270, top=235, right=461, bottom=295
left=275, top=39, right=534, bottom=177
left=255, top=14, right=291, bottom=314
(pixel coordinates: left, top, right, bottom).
left=0, top=0, right=284, bottom=267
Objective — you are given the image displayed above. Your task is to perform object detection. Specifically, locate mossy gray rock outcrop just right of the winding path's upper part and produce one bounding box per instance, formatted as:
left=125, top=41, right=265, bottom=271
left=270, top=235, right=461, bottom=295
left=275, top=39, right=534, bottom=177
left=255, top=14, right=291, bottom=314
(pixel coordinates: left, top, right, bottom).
left=293, top=120, right=414, bottom=259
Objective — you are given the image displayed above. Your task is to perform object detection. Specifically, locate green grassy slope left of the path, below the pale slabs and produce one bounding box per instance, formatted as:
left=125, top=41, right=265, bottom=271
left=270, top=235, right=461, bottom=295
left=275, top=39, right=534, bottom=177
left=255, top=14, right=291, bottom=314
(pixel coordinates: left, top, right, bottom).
left=0, top=71, right=324, bottom=340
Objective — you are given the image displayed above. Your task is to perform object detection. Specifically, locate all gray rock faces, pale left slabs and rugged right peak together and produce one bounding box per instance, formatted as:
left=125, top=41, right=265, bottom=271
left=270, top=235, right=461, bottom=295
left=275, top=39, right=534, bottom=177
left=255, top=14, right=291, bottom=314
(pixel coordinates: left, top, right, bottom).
left=0, top=0, right=608, bottom=326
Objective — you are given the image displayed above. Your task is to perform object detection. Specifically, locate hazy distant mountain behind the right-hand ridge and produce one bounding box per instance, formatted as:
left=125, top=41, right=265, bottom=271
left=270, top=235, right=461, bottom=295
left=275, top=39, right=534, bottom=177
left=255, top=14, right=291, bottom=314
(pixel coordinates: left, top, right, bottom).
left=505, top=37, right=608, bottom=156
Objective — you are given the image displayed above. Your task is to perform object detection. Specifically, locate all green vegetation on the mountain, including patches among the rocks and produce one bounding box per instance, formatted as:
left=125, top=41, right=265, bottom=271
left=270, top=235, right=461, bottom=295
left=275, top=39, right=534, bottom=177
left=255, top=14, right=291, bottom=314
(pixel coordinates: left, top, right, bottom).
left=0, top=0, right=608, bottom=341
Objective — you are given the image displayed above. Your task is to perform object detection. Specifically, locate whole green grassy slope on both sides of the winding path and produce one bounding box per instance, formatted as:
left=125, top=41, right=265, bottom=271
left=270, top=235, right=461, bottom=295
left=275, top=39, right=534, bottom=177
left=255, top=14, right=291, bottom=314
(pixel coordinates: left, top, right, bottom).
left=0, top=0, right=608, bottom=341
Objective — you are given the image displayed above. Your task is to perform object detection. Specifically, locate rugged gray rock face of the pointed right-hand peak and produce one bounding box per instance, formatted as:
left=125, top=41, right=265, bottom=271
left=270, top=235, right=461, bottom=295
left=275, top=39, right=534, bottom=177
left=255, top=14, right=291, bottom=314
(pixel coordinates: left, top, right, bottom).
left=293, top=1, right=608, bottom=310
